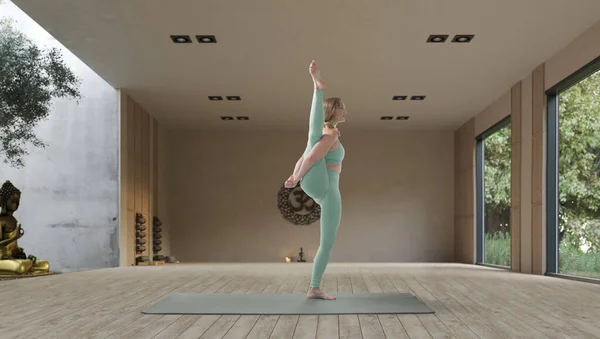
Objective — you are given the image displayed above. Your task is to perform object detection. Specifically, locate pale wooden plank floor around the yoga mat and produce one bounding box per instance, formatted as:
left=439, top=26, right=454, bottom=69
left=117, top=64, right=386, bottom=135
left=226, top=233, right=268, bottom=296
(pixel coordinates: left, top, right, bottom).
left=0, top=263, right=600, bottom=339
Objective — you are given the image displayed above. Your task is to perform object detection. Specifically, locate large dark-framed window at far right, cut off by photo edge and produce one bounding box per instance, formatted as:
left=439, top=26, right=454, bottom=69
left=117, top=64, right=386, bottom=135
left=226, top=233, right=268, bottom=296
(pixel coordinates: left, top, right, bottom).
left=547, top=58, right=600, bottom=279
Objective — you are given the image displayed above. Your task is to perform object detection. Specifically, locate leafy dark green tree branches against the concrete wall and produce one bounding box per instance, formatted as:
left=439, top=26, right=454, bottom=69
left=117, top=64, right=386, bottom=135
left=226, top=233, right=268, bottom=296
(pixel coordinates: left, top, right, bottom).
left=0, top=19, right=81, bottom=167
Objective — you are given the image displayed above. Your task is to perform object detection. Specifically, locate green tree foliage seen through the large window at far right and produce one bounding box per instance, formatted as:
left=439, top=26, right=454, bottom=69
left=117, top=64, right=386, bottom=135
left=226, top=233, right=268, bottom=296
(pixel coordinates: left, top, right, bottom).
left=558, top=72, right=600, bottom=249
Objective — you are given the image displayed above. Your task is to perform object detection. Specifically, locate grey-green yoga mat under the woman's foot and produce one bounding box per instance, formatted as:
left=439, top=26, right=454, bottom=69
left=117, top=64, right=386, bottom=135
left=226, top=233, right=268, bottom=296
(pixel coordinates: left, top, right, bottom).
left=142, top=293, right=434, bottom=315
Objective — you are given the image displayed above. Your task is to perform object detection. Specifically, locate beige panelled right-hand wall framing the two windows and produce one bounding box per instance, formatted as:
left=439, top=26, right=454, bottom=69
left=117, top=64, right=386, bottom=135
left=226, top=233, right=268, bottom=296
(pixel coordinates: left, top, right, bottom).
left=455, top=22, right=600, bottom=274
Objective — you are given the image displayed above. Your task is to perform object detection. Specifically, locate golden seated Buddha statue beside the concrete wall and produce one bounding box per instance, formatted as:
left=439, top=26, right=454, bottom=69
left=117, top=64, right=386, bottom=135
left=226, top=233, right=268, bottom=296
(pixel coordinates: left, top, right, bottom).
left=0, top=180, right=50, bottom=275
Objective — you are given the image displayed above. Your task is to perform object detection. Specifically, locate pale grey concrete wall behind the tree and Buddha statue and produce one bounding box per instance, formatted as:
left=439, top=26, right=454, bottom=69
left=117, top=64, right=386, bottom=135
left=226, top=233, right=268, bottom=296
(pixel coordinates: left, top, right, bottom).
left=0, top=1, right=119, bottom=272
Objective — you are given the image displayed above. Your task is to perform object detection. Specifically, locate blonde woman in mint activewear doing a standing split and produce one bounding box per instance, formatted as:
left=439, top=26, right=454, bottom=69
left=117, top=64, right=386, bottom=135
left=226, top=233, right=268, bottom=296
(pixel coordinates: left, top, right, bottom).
left=285, top=60, right=346, bottom=300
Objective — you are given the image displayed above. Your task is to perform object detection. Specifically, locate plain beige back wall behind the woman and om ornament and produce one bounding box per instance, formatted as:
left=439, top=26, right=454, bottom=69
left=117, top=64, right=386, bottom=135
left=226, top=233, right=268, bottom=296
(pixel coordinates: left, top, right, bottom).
left=166, top=131, right=454, bottom=262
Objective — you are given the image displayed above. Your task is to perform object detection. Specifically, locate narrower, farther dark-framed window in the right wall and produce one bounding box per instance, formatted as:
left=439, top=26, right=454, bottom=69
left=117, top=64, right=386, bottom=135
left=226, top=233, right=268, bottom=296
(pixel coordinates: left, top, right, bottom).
left=476, top=117, right=511, bottom=267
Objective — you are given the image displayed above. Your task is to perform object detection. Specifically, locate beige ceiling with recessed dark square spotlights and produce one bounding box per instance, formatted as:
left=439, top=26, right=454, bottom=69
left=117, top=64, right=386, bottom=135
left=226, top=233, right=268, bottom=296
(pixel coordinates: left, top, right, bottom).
left=8, top=0, right=600, bottom=130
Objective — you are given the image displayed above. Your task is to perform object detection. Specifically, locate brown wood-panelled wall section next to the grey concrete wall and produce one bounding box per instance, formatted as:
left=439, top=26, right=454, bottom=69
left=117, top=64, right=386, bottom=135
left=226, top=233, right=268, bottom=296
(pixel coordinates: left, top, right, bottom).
left=119, top=90, right=170, bottom=266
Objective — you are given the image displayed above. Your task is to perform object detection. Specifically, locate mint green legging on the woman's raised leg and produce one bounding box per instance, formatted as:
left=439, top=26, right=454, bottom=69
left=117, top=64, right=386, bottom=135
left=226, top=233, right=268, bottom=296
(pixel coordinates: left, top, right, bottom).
left=300, top=90, right=329, bottom=200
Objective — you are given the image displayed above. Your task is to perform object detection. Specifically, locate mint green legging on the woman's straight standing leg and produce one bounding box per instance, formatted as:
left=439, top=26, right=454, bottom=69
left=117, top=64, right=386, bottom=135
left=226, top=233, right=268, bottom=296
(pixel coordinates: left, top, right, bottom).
left=310, top=171, right=342, bottom=287
